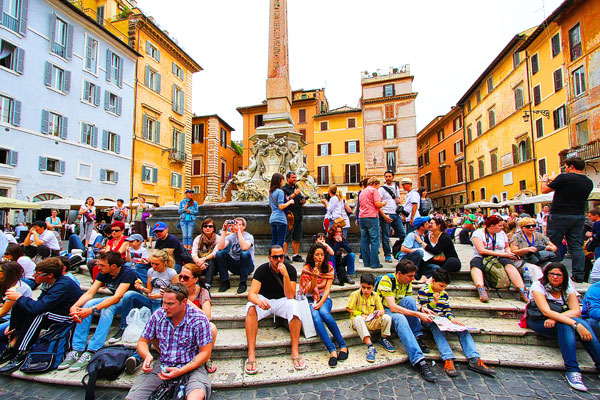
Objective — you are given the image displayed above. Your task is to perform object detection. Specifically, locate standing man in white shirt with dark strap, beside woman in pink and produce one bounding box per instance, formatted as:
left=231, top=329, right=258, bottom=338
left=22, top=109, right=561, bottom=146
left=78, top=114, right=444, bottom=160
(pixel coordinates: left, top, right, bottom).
left=379, top=171, right=406, bottom=262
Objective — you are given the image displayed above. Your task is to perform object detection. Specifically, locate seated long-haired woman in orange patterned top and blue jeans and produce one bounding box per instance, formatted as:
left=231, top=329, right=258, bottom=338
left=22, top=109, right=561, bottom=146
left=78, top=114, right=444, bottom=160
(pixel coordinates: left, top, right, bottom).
left=300, top=243, right=348, bottom=368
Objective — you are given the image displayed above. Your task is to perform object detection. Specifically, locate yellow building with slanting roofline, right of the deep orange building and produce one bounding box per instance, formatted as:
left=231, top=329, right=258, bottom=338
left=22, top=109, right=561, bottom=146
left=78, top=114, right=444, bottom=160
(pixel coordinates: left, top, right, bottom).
left=459, top=29, right=537, bottom=209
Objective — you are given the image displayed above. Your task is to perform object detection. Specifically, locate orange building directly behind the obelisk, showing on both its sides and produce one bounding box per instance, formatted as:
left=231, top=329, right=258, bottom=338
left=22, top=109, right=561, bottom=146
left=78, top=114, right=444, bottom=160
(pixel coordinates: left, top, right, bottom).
left=237, top=89, right=329, bottom=176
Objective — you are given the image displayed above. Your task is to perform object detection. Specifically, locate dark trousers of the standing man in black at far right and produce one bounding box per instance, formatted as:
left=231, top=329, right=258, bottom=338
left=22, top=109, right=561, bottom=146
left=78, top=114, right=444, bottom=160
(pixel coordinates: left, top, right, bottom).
left=547, top=214, right=585, bottom=280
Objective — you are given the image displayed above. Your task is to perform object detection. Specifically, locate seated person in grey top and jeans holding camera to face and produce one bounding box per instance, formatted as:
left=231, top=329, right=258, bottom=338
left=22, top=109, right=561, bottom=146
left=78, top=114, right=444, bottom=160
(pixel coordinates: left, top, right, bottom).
left=215, top=217, right=254, bottom=293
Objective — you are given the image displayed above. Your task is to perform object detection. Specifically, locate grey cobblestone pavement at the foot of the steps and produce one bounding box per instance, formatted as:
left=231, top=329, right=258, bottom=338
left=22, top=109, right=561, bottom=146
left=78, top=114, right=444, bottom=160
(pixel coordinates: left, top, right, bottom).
left=0, top=363, right=600, bottom=400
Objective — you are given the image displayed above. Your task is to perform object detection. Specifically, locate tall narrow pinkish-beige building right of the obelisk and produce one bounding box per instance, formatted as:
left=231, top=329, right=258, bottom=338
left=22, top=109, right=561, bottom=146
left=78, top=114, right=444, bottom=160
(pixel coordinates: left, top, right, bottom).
left=361, top=65, right=418, bottom=181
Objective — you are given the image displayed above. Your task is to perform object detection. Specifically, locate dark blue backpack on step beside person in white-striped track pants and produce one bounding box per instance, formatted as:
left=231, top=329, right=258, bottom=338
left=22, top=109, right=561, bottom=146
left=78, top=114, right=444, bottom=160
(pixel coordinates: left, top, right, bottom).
left=20, top=322, right=76, bottom=372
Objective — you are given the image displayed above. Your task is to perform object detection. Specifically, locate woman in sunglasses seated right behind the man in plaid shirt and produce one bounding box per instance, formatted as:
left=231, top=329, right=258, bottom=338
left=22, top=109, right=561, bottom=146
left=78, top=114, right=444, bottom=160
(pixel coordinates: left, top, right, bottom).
left=179, top=263, right=217, bottom=374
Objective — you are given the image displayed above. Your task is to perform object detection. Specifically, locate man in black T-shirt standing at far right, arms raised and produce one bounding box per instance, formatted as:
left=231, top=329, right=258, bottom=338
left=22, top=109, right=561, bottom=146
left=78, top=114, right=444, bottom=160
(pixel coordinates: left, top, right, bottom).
left=542, top=157, right=594, bottom=282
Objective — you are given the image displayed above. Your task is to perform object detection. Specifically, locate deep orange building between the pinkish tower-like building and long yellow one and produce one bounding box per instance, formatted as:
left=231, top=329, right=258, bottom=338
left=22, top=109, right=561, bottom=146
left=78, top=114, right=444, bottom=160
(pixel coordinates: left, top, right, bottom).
left=417, top=107, right=467, bottom=214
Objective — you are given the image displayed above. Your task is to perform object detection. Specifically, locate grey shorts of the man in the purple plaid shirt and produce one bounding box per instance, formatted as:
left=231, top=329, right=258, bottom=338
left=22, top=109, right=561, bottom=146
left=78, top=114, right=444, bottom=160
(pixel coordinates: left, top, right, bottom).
left=126, top=361, right=210, bottom=400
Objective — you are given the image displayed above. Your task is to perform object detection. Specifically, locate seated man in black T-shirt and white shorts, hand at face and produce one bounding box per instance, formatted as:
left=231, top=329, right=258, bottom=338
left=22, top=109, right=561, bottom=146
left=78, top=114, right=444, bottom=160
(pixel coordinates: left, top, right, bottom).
left=244, top=245, right=306, bottom=375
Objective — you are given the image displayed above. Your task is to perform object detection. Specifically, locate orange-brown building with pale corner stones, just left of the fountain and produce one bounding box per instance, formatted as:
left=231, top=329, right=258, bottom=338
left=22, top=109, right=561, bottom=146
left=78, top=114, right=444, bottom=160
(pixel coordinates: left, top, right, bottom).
left=191, top=114, right=242, bottom=204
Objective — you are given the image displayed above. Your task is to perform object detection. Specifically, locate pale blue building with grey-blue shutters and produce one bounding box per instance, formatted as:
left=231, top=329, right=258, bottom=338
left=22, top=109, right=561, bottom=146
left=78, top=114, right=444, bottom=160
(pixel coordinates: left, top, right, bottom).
left=0, top=0, right=139, bottom=201
